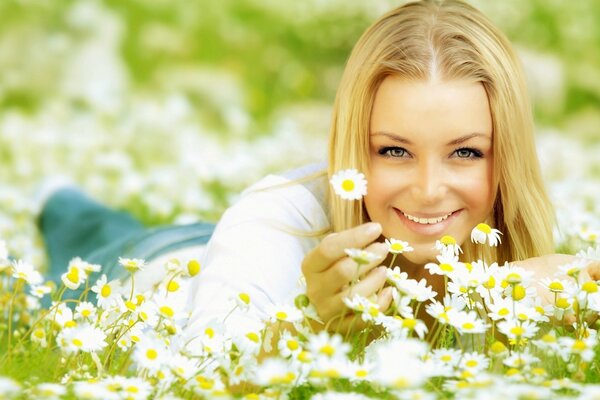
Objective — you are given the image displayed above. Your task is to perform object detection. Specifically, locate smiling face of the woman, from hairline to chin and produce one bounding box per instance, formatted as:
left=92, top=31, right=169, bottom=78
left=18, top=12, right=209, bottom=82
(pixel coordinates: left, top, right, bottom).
left=364, top=76, right=496, bottom=264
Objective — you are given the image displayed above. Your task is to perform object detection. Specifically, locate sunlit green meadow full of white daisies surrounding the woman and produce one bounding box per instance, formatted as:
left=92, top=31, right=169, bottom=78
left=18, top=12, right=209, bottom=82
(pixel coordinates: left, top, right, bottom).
left=0, top=0, right=600, bottom=399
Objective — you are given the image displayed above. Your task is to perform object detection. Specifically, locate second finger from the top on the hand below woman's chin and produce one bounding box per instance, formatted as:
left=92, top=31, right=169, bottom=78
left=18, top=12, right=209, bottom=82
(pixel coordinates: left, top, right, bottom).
left=317, top=243, right=388, bottom=294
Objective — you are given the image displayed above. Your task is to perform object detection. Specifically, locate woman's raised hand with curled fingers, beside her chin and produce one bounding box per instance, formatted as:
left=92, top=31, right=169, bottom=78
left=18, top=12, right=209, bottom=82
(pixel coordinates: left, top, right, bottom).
left=302, top=222, right=392, bottom=333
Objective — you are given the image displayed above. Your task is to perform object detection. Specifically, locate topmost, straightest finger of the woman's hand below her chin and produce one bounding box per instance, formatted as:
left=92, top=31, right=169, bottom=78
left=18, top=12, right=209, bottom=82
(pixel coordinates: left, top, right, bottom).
left=302, top=222, right=381, bottom=275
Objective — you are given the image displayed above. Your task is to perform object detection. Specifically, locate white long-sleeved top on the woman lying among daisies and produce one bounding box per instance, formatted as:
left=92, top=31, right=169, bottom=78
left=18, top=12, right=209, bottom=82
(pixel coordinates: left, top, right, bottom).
left=186, top=164, right=329, bottom=334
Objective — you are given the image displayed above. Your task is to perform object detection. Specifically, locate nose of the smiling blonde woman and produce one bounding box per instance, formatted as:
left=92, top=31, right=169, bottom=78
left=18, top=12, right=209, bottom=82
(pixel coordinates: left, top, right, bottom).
left=412, top=159, right=448, bottom=204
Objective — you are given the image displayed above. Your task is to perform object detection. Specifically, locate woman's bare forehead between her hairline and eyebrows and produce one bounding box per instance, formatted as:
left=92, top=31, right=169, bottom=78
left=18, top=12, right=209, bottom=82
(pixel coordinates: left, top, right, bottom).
left=370, top=76, right=492, bottom=140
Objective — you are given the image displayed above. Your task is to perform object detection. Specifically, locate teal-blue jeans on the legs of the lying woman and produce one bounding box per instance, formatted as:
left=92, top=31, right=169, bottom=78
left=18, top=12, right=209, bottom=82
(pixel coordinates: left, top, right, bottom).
left=39, top=188, right=214, bottom=298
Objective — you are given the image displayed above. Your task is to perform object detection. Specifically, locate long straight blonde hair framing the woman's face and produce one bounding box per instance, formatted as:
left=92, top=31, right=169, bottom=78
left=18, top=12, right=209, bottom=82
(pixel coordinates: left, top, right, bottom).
left=328, top=0, right=554, bottom=262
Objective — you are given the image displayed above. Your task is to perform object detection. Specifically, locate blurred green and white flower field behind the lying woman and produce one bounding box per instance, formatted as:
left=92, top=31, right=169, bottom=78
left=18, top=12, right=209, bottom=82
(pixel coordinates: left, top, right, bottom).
left=0, top=0, right=600, bottom=266
